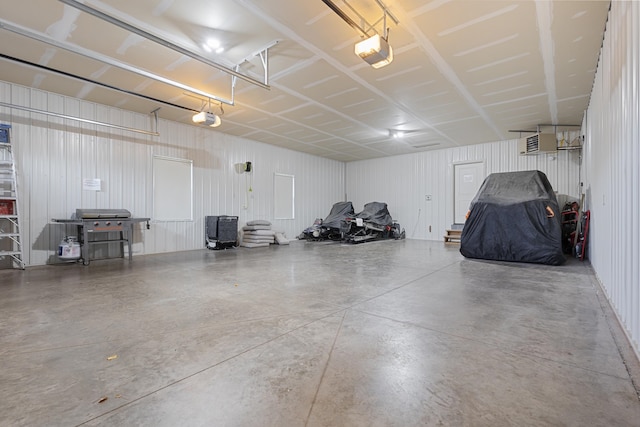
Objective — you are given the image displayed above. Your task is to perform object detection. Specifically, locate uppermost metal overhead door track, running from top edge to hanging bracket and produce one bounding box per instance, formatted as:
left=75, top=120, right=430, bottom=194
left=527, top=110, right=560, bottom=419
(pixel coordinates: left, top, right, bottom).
left=59, top=0, right=271, bottom=89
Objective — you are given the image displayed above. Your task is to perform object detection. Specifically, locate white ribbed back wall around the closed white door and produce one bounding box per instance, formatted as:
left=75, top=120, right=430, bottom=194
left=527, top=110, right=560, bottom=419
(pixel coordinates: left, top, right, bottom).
left=347, top=139, right=581, bottom=240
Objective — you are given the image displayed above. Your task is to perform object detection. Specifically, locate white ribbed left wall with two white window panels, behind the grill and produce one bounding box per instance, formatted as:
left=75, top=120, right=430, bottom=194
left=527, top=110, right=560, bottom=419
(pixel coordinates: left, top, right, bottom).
left=0, top=82, right=345, bottom=265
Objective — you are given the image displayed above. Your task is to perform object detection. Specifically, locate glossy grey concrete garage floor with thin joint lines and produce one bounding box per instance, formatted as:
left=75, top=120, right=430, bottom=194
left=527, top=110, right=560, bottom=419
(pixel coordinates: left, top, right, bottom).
left=0, top=240, right=640, bottom=427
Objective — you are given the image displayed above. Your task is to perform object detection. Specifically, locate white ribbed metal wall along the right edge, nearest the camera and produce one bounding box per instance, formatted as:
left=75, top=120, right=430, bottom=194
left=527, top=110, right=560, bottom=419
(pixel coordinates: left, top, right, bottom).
left=584, top=1, right=640, bottom=355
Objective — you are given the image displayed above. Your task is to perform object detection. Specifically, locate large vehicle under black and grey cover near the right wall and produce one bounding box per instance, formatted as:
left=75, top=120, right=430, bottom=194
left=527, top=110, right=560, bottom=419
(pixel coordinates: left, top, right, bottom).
left=460, top=171, right=565, bottom=265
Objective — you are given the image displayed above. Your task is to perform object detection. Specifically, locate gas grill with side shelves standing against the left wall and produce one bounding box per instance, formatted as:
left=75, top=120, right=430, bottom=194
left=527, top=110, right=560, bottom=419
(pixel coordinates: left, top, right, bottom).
left=53, top=209, right=150, bottom=265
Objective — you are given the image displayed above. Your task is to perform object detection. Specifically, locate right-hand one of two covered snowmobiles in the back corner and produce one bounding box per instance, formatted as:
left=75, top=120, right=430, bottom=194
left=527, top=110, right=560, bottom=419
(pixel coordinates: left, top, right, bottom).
left=344, top=202, right=405, bottom=243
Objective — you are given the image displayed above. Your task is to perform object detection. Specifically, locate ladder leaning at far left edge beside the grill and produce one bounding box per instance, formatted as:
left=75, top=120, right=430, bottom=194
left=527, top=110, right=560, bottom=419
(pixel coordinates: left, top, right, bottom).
left=0, top=124, right=24, bottom=269
